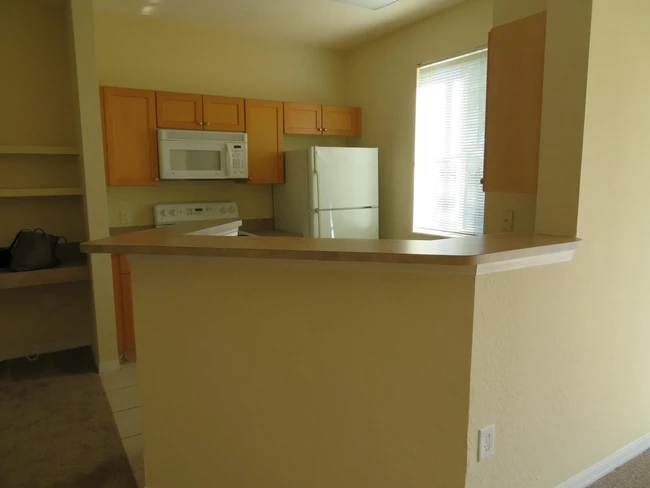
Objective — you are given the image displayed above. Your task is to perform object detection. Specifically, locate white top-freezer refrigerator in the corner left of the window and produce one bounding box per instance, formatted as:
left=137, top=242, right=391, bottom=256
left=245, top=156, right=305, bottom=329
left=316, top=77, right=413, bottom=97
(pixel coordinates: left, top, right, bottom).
left=273, top=146, right=379, bottom=239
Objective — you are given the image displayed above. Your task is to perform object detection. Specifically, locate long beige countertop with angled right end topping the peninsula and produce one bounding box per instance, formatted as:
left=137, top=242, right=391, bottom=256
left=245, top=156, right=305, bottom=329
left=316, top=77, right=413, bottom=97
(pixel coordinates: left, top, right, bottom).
left=81, top=220, right=580, bottom=272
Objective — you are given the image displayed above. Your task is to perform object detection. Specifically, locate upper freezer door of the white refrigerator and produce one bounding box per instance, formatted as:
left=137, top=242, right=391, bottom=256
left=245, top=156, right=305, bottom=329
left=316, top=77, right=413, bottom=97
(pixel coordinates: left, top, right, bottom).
left=311, top=147, right=379, bottom=210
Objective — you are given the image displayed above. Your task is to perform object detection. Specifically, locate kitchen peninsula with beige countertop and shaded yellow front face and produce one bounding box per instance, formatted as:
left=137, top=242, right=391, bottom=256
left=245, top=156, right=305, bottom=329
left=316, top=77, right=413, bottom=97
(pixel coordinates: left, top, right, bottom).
left=82, top=228, right=579, bottom=488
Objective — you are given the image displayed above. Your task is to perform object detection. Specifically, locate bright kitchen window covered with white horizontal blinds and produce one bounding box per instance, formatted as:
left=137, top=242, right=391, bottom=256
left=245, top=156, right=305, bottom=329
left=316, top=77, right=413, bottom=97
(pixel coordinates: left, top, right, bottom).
left=413, top=49, right=487, bottom=235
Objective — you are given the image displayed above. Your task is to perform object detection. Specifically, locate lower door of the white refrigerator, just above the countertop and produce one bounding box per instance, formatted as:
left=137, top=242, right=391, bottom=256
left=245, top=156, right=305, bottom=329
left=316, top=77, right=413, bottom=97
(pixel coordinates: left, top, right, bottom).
left=312, top=208, right=379, bottom=239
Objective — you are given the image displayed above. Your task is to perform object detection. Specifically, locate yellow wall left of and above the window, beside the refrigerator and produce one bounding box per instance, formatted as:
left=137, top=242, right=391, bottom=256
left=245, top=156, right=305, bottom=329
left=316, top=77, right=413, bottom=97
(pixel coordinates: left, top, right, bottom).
left=347, top=0, right=492, bottom=239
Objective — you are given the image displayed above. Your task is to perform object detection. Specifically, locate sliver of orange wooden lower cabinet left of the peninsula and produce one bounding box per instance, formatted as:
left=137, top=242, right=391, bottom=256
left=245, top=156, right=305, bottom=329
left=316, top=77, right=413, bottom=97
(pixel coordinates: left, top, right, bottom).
left=112, top=254, right=136, bottom=362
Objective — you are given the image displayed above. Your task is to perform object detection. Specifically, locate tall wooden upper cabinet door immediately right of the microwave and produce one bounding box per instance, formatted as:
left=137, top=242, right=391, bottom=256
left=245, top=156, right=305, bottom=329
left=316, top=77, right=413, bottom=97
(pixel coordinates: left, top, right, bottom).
left=246, top=100, right=284, bottom=184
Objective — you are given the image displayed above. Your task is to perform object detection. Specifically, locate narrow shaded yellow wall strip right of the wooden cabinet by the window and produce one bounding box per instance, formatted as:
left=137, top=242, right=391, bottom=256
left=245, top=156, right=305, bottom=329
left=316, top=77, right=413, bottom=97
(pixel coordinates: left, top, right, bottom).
left=536, top=0, right=591, bottom=236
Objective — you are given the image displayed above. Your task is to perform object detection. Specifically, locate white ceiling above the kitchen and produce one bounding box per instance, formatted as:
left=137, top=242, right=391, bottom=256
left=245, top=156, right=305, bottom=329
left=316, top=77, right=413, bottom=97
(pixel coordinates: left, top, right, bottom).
left=93, top=0, right=464, bottom=49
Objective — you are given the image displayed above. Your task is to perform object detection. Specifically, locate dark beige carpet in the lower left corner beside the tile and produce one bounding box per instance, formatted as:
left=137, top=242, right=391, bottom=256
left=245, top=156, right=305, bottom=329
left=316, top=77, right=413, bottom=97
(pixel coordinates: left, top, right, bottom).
left=0, top=348, right=136, bottom=488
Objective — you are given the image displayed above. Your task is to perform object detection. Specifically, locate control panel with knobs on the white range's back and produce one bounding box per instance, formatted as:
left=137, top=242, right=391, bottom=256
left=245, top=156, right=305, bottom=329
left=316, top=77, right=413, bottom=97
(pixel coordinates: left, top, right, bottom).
left=153, top=202, right=239, bottom=227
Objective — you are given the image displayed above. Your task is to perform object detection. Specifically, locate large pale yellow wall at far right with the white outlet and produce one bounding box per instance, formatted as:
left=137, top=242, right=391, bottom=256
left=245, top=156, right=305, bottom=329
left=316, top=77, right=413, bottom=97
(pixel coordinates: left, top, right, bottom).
left=467, top=0, right=650, bottom=488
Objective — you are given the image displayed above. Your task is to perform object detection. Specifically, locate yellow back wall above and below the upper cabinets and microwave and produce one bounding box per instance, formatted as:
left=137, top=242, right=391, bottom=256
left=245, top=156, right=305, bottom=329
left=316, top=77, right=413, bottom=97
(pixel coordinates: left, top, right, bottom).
left=95, top=12, right=345, bottom=226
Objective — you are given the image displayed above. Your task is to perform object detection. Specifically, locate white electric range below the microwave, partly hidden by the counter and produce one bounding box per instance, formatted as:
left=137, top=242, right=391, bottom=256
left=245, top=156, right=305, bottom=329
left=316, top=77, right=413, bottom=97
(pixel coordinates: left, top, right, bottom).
left=153, top=202, right=253, bottom=237
